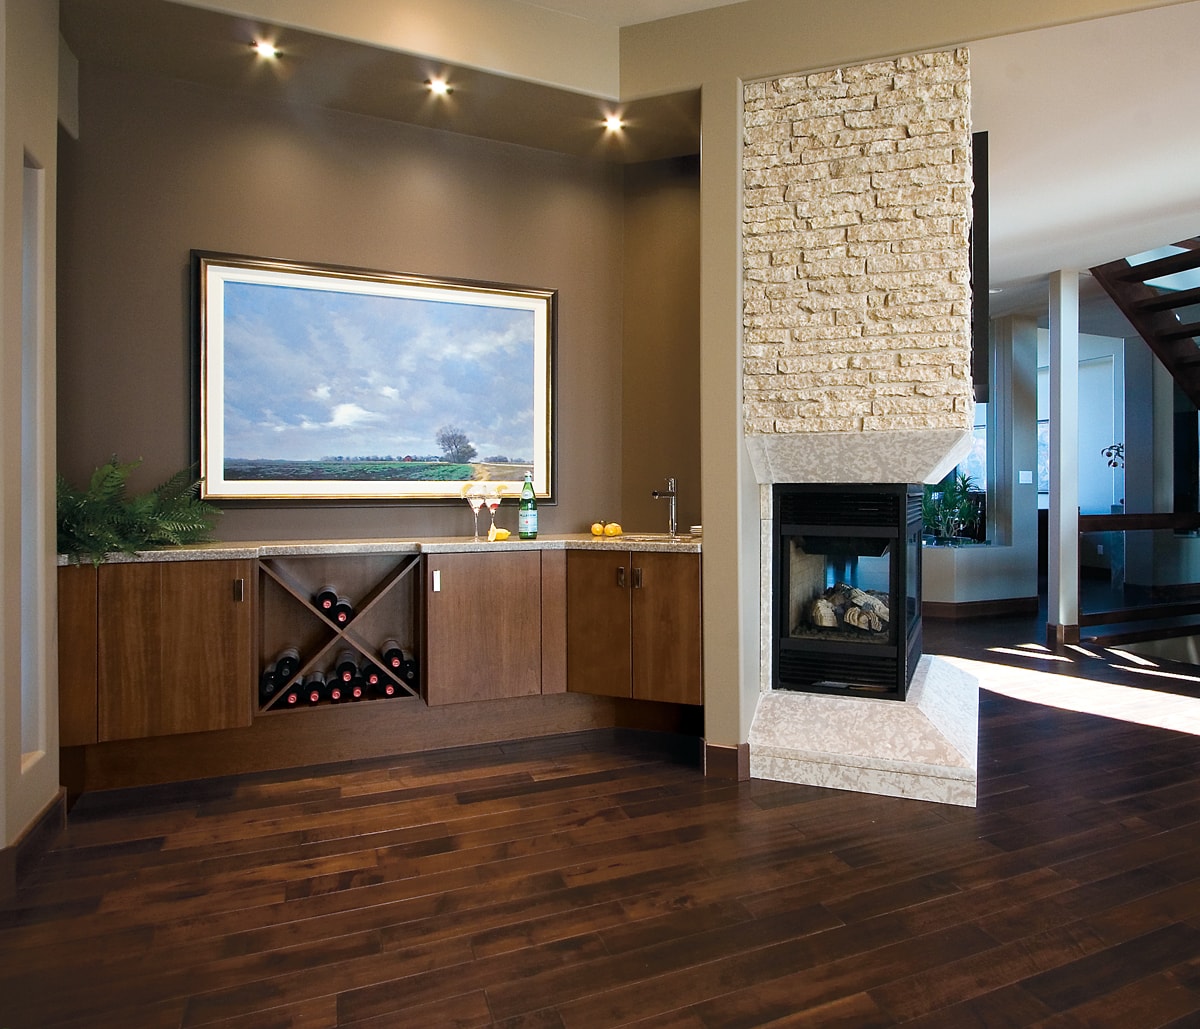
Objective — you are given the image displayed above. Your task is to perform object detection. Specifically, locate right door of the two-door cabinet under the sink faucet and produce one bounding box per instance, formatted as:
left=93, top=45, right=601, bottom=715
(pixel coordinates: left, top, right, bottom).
left=631, top=553, right=702, bottom=704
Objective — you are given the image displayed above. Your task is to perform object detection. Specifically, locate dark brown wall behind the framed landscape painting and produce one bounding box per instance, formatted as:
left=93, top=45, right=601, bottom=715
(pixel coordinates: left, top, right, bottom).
left=58, top=66, right=698, bottom=540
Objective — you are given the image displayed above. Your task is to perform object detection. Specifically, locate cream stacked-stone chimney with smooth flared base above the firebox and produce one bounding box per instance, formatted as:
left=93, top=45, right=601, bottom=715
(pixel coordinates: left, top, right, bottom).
left=743, top=49, right=973, bottom=483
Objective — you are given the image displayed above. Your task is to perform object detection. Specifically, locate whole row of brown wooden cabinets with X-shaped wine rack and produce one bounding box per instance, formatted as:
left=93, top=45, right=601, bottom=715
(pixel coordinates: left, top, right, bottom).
left=59, top=546, right=701, bottom=746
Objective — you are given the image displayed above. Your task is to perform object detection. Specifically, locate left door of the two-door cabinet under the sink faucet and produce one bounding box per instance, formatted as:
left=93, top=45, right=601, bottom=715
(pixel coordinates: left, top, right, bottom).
left=566, top=550, right=632, bottom=697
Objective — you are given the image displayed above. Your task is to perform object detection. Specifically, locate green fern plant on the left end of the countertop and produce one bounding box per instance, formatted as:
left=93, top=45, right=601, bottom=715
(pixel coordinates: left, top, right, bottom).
left=58, top=455, right=221, bottom=565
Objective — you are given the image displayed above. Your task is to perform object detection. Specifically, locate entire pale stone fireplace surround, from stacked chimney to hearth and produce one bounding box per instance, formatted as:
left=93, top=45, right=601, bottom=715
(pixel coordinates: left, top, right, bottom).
left=743, top=49, right=978, bottom=806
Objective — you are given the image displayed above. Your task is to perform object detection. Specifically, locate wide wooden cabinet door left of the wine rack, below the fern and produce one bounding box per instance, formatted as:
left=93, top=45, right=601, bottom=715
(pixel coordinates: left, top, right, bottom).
left=97, top=561, right=253, bottom=740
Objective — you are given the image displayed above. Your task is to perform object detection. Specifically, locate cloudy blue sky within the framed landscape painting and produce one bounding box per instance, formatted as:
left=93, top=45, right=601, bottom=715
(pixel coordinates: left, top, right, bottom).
left=224, top=282, right=534, bottom=461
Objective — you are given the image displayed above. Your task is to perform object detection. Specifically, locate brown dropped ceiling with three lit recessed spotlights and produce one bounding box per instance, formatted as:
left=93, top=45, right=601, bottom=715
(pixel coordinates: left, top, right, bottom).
left=59, top=0, right=700, bottom=163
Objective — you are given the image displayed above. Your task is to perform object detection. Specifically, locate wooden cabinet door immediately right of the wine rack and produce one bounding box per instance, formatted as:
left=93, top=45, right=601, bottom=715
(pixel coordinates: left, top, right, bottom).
left=422, top=550, right=541, bottom=706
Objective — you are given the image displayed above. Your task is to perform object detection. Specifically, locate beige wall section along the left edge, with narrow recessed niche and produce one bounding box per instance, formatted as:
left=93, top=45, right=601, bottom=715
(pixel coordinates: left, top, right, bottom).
left=0, top=0, right=59, bottom=849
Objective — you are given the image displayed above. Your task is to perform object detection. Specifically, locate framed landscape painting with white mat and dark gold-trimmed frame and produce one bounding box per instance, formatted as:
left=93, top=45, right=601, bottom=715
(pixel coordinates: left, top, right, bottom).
left=192, top=251, right=556, bottom=500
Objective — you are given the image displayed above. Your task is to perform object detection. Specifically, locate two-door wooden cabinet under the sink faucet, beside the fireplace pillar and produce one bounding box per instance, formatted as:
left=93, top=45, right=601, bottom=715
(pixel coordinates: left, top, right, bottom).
left=566, top=550, right=702, bottom=704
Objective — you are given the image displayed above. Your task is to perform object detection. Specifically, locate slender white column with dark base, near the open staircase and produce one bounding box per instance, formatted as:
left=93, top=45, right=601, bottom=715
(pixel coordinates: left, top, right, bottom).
left=1046, top=271, right=1079, bottom=643
